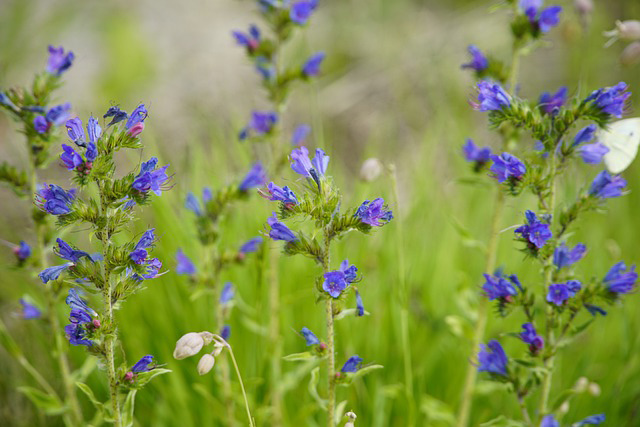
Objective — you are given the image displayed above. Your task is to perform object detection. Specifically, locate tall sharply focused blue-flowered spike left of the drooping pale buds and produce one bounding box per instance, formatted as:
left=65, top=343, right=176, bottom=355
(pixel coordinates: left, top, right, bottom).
left=35, top=105, right=171, bottom=426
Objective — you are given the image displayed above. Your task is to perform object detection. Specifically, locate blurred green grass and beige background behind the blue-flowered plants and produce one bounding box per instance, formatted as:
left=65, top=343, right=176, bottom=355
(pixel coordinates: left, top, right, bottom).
left=0, top=0, right=640, bottom=427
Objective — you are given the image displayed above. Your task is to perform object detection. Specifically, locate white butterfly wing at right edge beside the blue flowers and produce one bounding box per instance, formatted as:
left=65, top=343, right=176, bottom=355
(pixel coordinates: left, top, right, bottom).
left=598, top=117, right=640, bottom=174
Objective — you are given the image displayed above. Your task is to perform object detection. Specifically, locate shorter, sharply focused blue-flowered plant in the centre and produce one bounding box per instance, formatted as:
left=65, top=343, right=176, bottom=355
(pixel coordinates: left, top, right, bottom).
left=263, top=146, right=393, bottom=426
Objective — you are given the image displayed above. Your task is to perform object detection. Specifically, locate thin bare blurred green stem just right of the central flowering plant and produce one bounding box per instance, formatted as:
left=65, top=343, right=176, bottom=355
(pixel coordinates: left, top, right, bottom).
left=389, top=165, right=416, bottom=426
